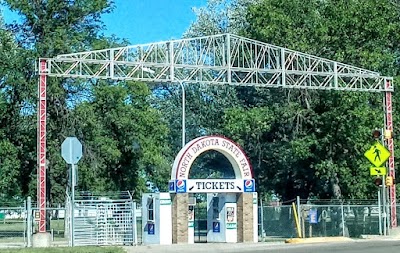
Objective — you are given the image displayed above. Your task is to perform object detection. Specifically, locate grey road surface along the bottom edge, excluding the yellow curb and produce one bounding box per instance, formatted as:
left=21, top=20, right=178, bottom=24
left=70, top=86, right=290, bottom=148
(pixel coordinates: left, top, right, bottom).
left=125, top=240, right=400, bottom=253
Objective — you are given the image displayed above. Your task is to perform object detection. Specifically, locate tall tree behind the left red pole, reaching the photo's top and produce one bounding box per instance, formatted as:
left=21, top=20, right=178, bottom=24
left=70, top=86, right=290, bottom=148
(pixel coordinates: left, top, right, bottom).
left=4, top=0, right=119, bottom=202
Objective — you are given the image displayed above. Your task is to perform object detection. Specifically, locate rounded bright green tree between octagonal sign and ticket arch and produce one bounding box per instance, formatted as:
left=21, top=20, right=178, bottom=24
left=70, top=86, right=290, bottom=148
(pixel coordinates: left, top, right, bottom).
left=70, top=82, right=169, bottom=194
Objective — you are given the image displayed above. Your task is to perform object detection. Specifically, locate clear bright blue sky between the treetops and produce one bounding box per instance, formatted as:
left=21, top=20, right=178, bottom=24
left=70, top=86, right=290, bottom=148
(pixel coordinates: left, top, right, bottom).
left=0, top=0, right=207, bottom=45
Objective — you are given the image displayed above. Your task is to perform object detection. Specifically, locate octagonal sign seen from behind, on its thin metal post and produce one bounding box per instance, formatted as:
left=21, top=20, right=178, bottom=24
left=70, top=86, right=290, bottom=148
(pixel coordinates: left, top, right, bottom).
left=61, top=137, right=82, bottom=247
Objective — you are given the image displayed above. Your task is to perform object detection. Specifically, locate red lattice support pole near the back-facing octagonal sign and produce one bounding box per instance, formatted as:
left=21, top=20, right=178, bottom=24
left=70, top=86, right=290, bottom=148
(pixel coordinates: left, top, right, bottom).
left=37, top=60, right=47, bottom=233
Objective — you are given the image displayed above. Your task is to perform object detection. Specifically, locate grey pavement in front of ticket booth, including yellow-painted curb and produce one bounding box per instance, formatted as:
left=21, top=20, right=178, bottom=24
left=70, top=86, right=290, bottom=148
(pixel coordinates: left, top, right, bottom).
left=124, top=237, right=400, bottom=253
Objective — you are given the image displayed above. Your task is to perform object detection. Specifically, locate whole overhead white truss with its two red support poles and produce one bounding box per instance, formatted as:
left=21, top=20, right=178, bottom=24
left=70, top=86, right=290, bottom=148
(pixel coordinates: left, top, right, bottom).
left=37, top=34, right=397, bottom=235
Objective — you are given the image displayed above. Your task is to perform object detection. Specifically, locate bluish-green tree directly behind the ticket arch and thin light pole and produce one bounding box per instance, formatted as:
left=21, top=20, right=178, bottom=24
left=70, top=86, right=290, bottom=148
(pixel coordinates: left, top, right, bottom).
left=152, top=84, right=238, bottom=177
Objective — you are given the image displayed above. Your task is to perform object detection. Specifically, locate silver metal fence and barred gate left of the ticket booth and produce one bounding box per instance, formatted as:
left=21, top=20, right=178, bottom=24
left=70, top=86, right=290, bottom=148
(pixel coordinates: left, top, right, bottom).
left=0, top=193, right=140, bottom=248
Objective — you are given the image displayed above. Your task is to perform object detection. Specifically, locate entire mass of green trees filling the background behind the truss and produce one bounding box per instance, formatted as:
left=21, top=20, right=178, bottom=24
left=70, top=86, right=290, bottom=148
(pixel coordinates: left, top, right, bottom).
left=0, top=0, right=400, bottom=202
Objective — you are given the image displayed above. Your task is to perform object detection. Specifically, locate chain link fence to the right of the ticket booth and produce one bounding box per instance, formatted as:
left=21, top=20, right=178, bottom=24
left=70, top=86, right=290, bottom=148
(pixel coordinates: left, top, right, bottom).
left=259, top=200, right=400, bottom=240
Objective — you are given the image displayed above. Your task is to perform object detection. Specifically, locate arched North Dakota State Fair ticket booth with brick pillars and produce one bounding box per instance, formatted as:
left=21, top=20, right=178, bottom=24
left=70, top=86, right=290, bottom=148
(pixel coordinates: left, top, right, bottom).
left=142, top=136, right=258, bottom=244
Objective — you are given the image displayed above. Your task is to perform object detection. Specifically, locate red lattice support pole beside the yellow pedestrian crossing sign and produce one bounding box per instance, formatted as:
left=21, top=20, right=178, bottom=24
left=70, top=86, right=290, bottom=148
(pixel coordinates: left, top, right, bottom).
left=385, top=80, right=397, bottom=228
